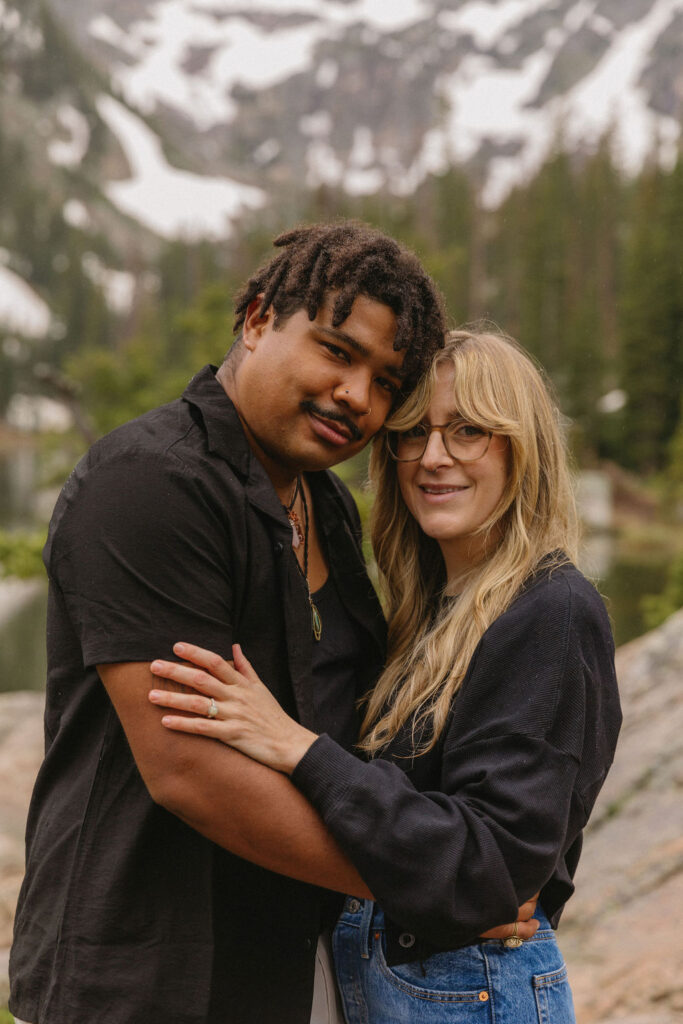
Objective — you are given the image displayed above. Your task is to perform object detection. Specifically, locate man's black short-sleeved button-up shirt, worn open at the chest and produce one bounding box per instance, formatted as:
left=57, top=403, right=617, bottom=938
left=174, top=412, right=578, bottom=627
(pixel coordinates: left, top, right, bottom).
left=10, top=368, right=384, bottom=1024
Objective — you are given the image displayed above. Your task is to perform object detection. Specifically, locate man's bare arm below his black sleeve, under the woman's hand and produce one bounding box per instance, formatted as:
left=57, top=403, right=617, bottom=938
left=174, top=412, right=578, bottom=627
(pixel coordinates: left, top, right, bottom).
left=98, top=663, right=370, bottom=897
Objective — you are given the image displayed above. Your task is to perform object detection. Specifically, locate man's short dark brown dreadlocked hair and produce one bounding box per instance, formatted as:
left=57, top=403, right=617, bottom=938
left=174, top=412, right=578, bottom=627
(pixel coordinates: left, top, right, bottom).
left=233, top=220, right=444, bottom=387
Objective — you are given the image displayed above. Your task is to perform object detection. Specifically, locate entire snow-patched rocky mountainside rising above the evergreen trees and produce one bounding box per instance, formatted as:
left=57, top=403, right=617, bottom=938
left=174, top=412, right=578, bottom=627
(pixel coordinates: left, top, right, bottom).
left=0, top=0, right=683, bottom=352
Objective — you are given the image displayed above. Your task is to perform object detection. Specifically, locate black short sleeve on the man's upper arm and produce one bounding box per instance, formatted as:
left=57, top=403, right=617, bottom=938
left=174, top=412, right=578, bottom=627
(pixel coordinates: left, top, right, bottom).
left=46, top=452, right=232, bottom=666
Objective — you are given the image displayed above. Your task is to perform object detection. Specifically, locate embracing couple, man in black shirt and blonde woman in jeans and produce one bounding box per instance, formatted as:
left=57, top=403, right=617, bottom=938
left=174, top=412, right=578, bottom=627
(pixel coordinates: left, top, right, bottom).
left=10, top=222, right=621, bottom=1024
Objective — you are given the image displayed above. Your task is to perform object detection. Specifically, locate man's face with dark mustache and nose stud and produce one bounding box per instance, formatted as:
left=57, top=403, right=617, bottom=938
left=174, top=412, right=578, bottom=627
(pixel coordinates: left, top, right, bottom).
left=233, top=296, right=403, bottom=476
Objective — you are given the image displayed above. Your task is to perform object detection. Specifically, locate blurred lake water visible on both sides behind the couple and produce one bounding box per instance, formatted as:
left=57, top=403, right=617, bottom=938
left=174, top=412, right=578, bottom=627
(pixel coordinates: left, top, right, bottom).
left=0, top=447, right=668, bottom=692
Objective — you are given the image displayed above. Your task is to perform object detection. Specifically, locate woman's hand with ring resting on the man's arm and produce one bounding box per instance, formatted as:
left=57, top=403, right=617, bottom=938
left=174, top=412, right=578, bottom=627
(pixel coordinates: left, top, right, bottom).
left=150, top=643, right=317, bottom=774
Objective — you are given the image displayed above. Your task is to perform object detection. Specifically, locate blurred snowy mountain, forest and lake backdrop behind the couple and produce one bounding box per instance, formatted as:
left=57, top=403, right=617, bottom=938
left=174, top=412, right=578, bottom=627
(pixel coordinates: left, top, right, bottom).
left=0, top=0, right=683, bottom=1024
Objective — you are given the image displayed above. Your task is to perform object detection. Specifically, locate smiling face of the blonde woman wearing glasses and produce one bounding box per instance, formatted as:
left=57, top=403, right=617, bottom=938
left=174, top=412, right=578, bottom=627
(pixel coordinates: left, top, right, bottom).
left=396, top=364, right=508, bottom=579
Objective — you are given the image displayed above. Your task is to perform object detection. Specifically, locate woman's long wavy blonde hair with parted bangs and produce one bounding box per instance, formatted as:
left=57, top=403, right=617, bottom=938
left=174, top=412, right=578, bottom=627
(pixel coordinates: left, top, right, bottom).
left=358, top=328, right=579, bottom=754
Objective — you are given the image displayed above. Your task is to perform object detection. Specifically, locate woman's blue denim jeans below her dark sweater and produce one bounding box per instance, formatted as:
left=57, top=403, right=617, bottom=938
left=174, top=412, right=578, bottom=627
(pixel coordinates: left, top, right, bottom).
left=333, top=899, right=575, bottom=1024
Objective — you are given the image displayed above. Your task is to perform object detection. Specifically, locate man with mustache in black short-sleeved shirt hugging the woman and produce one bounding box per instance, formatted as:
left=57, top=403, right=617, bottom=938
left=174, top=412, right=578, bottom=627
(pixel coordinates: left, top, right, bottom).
left=10, top=223, right=443, bottom=1024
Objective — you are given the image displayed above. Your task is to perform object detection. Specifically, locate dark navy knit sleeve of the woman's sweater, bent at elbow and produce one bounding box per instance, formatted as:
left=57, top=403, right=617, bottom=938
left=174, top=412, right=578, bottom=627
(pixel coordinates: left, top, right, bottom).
left=292, top=569, right=618, bottom=947
